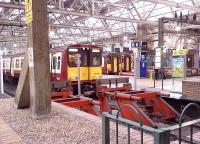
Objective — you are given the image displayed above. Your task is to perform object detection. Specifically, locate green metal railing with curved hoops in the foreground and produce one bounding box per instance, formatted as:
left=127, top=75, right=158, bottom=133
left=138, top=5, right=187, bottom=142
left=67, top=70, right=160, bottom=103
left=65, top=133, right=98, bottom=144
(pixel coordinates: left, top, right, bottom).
left=102, top=103, right=200, bottom=144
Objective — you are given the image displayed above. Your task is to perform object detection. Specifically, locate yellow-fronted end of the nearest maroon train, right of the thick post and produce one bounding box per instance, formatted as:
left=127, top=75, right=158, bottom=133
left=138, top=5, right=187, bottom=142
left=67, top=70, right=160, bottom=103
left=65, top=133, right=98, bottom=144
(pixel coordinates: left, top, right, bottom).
left=51, top=44, right=102, bottom=95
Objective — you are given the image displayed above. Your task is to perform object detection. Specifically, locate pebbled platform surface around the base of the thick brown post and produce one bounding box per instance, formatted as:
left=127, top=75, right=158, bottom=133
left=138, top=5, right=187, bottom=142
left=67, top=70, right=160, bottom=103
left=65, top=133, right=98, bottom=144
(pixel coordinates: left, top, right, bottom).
left=0, top=98, right=147, bottom=144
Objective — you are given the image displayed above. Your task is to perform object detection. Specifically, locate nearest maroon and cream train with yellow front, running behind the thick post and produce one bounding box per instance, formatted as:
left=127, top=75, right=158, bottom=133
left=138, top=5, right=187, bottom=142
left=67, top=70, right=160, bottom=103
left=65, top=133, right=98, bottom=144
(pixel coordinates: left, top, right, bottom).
left=3, top=44, right=102, bottom=94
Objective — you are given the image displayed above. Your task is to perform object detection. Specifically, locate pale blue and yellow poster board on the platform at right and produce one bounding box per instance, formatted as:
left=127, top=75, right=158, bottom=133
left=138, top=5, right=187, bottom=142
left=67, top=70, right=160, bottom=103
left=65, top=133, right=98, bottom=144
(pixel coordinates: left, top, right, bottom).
left=172, top=56, right=184, bottom=78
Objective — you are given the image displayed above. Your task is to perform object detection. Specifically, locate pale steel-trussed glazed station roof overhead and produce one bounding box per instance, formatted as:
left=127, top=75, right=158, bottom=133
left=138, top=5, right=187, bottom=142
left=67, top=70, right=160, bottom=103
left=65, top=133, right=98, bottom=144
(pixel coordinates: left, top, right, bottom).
left=0, top=0, right=200, bottom=51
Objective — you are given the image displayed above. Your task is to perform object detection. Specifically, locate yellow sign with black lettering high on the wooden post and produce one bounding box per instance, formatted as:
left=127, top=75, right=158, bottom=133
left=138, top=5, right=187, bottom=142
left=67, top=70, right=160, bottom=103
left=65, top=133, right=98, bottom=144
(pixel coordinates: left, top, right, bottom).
left=25, top=0, right=33, bottom=24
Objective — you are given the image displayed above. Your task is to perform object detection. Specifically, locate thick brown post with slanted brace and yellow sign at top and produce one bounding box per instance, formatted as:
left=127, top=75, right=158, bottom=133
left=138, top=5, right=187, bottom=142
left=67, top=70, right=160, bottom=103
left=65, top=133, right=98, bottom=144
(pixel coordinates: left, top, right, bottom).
left=15, top=0, right=51, bottom=119
